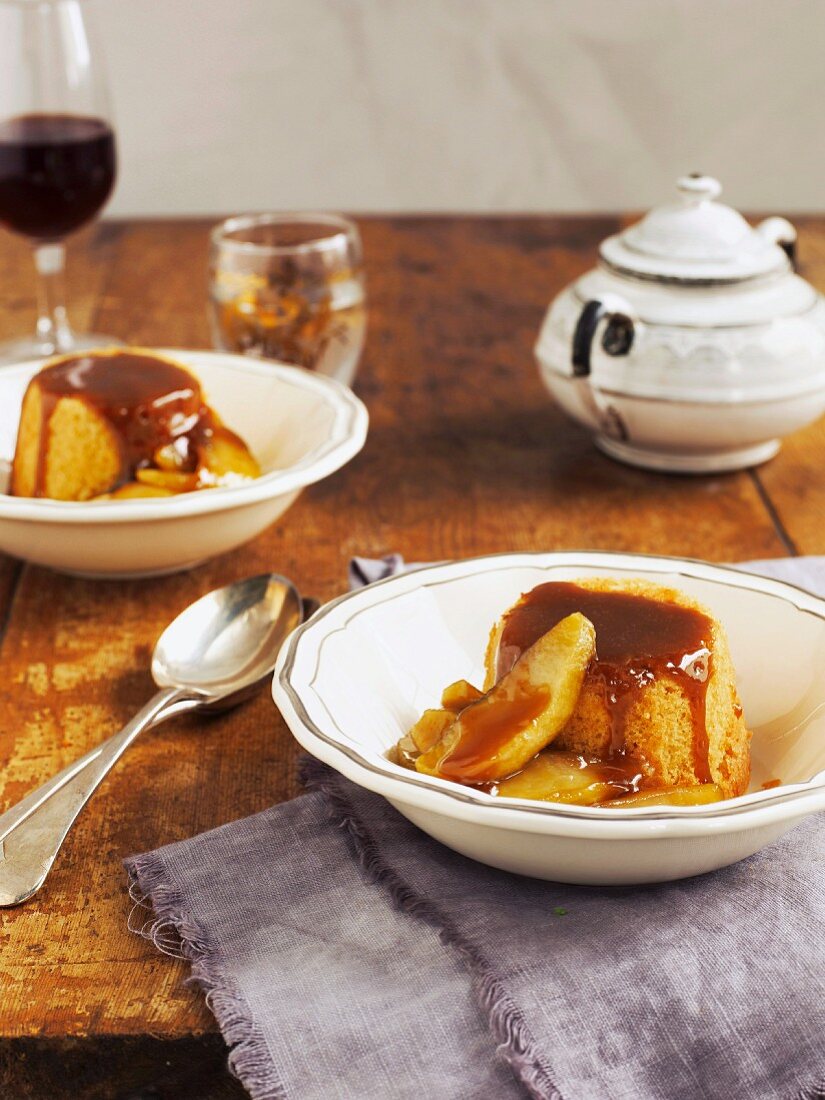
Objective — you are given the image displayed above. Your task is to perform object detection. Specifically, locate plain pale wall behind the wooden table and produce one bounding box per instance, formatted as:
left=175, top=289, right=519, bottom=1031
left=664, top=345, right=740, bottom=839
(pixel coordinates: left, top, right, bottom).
left=98, top=0, right=825, bottom=215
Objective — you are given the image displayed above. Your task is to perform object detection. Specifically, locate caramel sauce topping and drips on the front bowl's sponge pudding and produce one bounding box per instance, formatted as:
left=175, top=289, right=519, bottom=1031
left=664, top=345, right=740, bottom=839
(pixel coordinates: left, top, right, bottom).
left=496, top=581, right=712, bottom=782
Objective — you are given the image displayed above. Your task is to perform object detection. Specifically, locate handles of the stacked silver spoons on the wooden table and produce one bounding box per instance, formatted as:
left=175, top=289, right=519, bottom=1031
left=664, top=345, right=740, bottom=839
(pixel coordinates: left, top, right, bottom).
left=0, top=688, right=201, bottom=906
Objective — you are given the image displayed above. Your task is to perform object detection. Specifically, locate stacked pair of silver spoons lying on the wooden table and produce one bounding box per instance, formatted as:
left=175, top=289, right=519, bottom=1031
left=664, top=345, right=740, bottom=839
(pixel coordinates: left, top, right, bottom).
left=0, top=573, right=308, bottom=906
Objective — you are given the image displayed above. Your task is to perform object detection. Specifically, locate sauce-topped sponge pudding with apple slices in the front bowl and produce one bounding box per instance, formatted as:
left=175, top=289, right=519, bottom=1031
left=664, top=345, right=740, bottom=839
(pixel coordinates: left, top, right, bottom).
left=392, top=578, right=750, bottom=809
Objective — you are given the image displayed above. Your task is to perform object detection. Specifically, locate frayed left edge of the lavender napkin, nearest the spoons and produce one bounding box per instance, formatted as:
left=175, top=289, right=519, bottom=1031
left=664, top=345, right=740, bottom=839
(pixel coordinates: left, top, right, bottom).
left=123, top=853, right=286, bottom=1100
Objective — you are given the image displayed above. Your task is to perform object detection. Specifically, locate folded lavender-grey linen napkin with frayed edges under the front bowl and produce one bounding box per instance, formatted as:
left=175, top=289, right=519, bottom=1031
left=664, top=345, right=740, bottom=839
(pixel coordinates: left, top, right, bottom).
left=127, top=558, right=825, bottom=1100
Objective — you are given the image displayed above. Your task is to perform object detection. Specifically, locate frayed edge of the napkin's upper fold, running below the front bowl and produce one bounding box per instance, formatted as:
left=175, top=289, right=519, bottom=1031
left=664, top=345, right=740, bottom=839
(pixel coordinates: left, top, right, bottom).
left=299, top=757, right=563, bottom=1100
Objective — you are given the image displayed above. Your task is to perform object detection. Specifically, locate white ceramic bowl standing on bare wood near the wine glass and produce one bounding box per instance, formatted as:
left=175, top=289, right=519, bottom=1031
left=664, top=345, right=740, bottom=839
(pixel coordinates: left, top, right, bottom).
left=0, top=349, right=367, bottom=576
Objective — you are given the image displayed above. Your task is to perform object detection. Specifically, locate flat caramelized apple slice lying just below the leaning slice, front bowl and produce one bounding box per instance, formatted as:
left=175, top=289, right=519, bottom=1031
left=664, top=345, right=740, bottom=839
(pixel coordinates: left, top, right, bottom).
left=497, top=749, right=629, bottom=806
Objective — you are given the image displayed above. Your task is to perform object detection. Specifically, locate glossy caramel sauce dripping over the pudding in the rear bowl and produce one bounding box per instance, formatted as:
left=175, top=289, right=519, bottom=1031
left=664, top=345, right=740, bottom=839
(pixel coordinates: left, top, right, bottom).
left=34, top=351, right=223, bottom=496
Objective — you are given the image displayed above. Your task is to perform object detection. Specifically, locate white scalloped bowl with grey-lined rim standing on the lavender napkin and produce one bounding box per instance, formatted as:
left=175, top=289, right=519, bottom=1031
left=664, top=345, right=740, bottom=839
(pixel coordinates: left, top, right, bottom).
left=273, top=552, right=825, bottom=886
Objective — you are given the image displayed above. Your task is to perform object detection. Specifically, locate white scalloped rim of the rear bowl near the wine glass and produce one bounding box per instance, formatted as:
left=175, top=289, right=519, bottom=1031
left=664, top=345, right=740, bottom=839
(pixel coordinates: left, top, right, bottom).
left=0, top=348, right=370, bottom=525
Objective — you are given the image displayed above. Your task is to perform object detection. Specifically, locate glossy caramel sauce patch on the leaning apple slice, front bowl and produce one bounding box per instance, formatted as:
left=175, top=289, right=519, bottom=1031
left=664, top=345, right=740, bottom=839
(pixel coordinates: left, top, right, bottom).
left=438, top=689, right=550, bottom=783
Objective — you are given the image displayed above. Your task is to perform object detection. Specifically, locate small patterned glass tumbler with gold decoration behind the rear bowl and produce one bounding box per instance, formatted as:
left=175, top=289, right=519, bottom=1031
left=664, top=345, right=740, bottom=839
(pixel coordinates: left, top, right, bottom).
left=209, top=213, right=366, bottom=386
